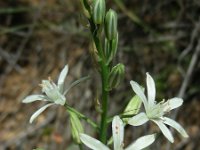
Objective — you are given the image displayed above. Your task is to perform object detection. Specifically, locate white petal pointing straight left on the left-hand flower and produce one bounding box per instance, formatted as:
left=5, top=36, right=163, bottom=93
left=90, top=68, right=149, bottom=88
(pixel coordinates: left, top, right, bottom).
left=22, top=95, right=50, bottom=103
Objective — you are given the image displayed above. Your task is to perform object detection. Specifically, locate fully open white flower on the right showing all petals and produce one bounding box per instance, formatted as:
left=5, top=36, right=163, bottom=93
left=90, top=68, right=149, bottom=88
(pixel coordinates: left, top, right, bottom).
left=128, top=73, right=188, bottom=143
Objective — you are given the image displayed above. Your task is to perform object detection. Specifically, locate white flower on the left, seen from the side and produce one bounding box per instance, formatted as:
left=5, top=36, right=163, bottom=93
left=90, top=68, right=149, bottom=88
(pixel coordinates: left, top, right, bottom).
left=22, top=65, right=68, bottom=123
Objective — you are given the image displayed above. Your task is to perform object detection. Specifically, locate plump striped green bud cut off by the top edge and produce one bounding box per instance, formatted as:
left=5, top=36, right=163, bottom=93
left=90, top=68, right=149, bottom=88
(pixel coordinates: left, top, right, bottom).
left=93, top=0, right=106, bottom=24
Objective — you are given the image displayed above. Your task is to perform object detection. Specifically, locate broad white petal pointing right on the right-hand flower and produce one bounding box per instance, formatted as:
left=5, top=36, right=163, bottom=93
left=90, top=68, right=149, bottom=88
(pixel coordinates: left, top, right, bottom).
left=163, top=97, right=183, bottom=112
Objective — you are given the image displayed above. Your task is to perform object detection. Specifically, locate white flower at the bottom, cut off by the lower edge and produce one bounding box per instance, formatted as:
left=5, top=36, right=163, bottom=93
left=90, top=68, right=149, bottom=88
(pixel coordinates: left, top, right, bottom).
left=80, top=116, right=155, bottom=150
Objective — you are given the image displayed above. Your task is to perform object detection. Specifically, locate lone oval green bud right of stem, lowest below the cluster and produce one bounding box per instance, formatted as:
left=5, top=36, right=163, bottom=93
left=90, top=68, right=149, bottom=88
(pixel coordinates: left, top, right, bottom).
left=108, top=63, right=125, bottom=90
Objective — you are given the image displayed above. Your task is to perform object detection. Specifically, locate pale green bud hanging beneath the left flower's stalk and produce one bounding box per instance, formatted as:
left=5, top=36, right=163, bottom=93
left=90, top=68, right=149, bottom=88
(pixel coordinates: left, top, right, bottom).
left=69, top=111, right=84, bottom=144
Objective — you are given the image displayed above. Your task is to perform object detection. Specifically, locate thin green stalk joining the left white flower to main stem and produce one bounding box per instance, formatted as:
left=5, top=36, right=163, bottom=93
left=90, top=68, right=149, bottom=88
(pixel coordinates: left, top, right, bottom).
left=65, top=104, right=99, bottom=131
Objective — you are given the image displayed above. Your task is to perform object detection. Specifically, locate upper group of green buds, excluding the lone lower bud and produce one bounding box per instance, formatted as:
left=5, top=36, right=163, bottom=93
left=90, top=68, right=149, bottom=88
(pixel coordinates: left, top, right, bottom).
left=81, top=0, right=118, bottom=64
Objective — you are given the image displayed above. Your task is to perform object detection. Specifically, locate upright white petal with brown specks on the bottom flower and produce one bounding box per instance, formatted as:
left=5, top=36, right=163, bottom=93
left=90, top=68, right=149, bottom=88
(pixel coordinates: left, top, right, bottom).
left=112, top=116, right=124, bottom=150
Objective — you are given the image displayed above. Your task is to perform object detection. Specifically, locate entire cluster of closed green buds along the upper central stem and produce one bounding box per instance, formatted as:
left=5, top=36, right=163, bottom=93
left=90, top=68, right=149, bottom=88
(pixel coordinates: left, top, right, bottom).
left=81, top=0, right=124, bottom=90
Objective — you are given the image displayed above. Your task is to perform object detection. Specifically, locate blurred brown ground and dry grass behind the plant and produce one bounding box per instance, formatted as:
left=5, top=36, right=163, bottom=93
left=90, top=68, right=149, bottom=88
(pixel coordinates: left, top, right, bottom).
left=0, top=0, right=200, bottom=150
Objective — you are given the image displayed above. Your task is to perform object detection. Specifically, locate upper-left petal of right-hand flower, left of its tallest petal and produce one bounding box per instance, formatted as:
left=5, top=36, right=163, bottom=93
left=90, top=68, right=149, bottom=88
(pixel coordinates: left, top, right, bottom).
left=130, top=81, right=148, bottom=109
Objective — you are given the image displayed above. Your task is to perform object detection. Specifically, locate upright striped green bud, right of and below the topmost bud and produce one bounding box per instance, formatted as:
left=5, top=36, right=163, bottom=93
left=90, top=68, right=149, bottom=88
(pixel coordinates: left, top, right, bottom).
left=105, top=9, right=117, bottom=40
